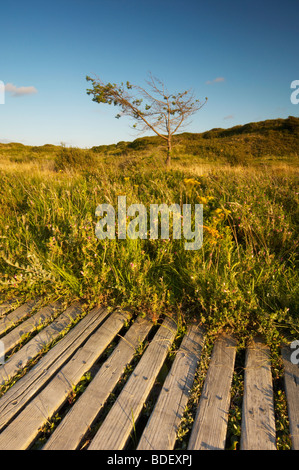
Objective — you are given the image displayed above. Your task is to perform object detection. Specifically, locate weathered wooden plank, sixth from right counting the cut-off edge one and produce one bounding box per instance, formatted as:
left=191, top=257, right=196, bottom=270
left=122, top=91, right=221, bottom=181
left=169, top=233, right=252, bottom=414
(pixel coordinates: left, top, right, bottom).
left=43, top=318, right=153, bottom=450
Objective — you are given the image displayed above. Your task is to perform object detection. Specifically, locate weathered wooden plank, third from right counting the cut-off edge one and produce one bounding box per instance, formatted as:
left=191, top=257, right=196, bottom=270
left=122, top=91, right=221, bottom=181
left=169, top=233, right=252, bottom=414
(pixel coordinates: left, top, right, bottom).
left=188, top=335, right=236, bottom=450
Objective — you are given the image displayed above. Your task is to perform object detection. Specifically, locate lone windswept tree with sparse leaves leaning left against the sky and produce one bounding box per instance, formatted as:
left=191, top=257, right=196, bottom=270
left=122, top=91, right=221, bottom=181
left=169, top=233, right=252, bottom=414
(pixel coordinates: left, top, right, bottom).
left=86, top=74, right=207, bottom=165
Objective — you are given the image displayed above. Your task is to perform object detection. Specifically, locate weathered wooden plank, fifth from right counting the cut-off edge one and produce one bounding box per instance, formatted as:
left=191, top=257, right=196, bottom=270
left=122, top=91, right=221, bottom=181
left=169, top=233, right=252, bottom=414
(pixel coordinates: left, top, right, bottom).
left=88, top=318, right=177, bottom=450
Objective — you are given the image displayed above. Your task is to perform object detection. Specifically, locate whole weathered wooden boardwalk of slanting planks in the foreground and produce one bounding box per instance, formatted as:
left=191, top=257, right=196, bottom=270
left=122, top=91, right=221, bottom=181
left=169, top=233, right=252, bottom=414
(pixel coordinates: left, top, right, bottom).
left=0, top=299, right=299, bottom=450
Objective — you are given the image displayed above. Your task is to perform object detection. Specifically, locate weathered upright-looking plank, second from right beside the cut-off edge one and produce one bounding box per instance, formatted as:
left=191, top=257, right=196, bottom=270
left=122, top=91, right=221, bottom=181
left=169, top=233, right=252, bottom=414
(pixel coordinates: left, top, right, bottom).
left=241, top=338, right=276, bottom=450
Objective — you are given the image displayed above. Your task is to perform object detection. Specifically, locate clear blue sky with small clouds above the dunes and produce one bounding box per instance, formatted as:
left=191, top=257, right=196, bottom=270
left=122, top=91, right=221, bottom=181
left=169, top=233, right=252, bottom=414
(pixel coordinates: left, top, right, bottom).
left=0, top=0, right=299, bottom=147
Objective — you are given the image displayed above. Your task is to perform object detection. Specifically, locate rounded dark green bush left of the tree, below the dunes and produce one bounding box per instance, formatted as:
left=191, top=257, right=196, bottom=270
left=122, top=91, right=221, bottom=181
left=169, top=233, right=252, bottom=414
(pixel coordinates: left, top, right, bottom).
left=55, top=147, right=96, bottom=171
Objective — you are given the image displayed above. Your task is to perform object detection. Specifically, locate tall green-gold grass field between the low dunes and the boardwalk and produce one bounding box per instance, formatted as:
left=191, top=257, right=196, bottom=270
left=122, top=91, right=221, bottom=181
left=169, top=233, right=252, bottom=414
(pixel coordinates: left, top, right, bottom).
left=0, top=152, right=299, bottom=346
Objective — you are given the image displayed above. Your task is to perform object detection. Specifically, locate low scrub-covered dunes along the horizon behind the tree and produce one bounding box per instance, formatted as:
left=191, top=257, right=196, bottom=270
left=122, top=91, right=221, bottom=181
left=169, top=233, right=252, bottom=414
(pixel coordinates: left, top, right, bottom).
left=0, top=116, right=299, bottom=169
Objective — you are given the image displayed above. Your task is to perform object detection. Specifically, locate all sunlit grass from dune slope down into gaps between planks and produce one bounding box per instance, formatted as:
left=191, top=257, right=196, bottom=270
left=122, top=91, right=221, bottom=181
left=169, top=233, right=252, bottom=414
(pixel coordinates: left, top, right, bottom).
left=0, top=122, right=299, bottom=449
